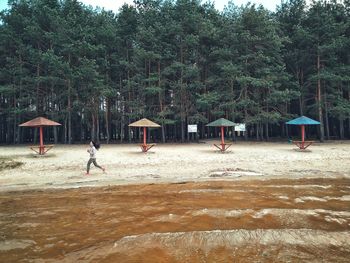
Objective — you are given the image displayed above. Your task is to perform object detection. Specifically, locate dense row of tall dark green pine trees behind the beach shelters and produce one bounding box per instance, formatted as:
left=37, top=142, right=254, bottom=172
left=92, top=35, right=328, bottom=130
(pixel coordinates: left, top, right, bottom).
left=0, top=0, right=350, bottom=143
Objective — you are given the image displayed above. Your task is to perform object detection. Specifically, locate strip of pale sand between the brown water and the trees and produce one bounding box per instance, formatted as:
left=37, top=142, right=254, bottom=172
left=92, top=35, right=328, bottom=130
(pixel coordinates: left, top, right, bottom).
left=0, top=141, right=350, bottom=191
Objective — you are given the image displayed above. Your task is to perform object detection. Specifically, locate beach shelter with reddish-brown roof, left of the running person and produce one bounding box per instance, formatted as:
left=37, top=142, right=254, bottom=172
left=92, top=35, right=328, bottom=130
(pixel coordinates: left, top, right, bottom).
left=19, top=117, right=61, bottom=155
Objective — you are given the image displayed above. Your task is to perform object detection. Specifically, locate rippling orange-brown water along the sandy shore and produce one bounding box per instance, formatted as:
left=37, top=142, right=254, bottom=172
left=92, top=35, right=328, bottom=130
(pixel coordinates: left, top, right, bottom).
left=0, top=179, right=350, bottom=262
